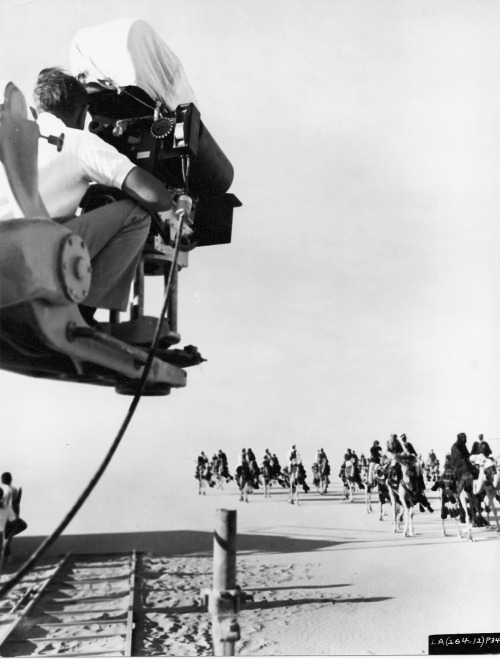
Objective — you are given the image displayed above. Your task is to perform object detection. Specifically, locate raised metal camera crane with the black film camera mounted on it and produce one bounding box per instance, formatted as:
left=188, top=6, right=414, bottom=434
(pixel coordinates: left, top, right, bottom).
left=0, top=77, right=241, bottom=395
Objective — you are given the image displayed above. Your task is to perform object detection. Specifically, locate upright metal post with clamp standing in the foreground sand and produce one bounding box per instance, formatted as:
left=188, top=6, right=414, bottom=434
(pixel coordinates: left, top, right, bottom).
left=209, top=510, right=240, bottom=657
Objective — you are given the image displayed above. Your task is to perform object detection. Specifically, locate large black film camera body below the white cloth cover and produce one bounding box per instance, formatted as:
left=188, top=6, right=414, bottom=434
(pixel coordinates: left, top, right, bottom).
left=87, top=84, right=241, bottom=246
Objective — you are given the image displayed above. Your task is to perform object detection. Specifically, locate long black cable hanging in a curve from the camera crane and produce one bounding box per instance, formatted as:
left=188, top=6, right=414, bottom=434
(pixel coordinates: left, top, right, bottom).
left=0, top=213, right=185, bottom=598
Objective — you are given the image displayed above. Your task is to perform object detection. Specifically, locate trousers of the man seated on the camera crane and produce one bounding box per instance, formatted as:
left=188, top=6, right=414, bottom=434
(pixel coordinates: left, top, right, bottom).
left=57, top=199, right=151, bottom=311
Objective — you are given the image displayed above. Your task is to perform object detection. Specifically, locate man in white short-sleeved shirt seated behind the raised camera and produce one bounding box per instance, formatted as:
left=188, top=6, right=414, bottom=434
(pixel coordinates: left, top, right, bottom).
left=34, top=68, right=178, bottom=324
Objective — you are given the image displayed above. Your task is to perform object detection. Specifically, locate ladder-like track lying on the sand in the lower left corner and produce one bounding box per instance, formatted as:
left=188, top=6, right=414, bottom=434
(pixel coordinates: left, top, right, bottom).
left=0, top=552, right=137, bottom=657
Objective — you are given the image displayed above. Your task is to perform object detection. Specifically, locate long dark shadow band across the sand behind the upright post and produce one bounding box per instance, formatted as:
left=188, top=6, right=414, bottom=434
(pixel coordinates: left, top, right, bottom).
left=13, top=530, right=352, bottom=562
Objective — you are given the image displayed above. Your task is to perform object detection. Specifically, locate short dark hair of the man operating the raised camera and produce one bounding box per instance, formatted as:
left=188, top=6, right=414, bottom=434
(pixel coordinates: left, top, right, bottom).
left=33, top=67, right=88, bottom=119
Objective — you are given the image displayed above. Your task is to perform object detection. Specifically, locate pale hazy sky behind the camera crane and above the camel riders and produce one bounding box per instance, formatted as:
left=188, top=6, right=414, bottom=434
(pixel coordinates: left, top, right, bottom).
left=0, top=0, right=500, bottom=532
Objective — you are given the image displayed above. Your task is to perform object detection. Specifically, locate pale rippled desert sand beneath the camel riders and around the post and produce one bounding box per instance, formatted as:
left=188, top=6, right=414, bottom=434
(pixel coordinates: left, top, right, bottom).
left=3, top=470, right=500, bottom=656
